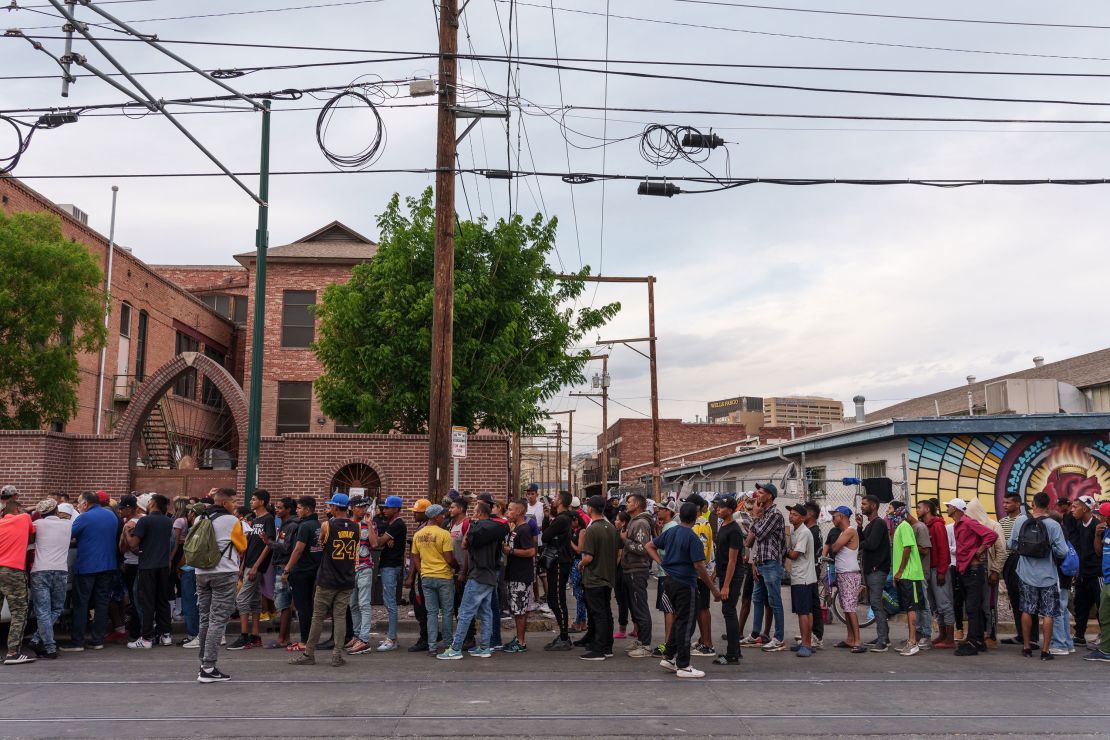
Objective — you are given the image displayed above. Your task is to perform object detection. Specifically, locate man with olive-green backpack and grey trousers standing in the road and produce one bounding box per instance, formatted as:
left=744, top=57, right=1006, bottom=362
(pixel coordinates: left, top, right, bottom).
left=185, top=488, right=246, bottom=683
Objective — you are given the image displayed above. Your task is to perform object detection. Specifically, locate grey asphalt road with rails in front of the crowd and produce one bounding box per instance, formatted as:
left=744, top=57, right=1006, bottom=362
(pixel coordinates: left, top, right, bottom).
left=0, top=603, right=1110, bottom=738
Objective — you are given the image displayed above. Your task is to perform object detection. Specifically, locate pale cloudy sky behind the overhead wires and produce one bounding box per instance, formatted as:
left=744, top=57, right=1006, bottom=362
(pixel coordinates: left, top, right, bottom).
left=0, top=0, right=1110, bottom=452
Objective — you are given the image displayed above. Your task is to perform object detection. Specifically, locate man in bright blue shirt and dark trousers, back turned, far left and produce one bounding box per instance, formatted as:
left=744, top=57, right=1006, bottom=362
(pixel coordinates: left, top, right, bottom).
left=58, top=491, right=120, bottom=652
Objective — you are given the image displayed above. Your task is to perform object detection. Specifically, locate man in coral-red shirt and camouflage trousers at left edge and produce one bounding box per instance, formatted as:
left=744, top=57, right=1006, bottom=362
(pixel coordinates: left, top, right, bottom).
left=0, top=486, right=34, bottom=666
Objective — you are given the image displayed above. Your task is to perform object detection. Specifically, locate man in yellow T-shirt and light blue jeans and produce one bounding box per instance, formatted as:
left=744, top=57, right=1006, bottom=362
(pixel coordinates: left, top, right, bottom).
left=413, top=504, right=456, bottom=656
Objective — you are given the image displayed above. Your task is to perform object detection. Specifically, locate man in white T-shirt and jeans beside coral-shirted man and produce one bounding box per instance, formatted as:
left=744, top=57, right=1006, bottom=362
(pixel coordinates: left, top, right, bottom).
left=31, top=498, right=72, bottom=659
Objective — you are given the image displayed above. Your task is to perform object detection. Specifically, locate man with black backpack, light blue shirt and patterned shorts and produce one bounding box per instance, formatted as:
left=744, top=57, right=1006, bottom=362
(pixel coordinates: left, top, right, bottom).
left=1009, top=491, right=1068, bottom=660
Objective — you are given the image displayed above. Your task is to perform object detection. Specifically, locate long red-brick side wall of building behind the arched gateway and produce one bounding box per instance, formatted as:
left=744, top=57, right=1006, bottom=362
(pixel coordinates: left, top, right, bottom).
left=0, top=176, right=235, bottom=434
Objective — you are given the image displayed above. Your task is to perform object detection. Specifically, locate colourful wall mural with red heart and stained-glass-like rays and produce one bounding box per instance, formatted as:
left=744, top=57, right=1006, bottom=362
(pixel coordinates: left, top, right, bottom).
left=909, top=434, right=1110, bottom=516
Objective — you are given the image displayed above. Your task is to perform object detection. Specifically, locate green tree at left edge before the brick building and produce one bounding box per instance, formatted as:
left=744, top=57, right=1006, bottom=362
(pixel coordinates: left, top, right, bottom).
left=0, top=211, right=105, bottom=429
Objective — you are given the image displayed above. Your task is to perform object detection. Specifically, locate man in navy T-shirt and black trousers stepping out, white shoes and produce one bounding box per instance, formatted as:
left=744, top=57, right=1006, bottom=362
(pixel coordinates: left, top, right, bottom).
left=645, top=501, right=720, bottom=678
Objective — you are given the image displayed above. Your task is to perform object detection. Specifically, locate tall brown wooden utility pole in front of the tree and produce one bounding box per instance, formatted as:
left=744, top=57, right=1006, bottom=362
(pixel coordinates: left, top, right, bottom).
left=427, top=0, right=458, bottom=501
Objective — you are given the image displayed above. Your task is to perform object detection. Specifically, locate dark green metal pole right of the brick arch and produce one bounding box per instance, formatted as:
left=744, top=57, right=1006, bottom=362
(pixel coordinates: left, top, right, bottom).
left=243, top=100, right=270, bottom=506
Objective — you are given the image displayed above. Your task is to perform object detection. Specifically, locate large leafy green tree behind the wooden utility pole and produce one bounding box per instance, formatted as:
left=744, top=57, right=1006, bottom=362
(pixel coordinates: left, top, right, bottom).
left=315, top=189, right=620, bottom=434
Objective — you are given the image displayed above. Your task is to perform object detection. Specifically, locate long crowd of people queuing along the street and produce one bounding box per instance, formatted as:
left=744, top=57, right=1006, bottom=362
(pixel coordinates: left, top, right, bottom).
left=0, top=484, right=1110, bottom=683
